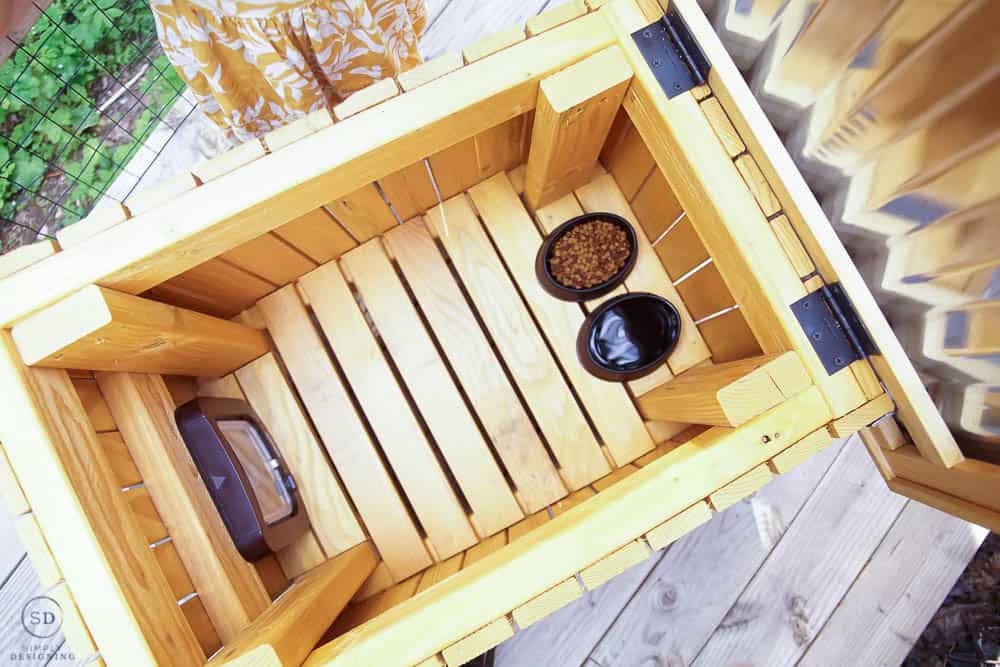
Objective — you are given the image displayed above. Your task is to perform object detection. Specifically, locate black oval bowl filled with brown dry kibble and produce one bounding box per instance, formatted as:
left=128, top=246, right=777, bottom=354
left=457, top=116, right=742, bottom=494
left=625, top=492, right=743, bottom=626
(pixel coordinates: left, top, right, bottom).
left=535, top=213, right=638, bottom=301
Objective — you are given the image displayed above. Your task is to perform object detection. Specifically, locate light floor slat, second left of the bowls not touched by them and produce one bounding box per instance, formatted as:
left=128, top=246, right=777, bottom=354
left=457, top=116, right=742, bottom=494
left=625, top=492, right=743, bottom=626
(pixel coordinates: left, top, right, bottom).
left=385, top=220, right=566, bottom=512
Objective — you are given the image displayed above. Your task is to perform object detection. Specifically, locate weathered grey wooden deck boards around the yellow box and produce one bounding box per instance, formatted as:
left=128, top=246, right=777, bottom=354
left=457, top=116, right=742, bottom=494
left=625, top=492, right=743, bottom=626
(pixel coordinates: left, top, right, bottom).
left=0, top=0, right=986, bottom=667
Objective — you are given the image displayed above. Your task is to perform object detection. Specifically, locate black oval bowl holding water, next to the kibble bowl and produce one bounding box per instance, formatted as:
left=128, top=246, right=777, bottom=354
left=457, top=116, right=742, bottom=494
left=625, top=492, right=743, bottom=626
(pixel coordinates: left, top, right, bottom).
left=576, top=292, right=681, bottom=382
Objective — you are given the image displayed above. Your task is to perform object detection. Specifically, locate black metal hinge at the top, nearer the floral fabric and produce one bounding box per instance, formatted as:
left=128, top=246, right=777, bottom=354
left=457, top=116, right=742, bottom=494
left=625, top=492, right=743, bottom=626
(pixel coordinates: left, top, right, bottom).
left=632, top=7, right=711, bottom=98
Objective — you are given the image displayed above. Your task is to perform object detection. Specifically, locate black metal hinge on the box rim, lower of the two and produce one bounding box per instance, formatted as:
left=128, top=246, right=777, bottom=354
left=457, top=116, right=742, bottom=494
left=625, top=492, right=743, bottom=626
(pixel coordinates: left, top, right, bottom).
left=791, top=283, right=878, bottom=375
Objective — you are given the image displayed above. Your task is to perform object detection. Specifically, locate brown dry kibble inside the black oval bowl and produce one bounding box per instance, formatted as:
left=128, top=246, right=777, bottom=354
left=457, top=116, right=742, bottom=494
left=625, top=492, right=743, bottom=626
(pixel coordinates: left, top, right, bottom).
left=549, top=220, right=629, bottom=289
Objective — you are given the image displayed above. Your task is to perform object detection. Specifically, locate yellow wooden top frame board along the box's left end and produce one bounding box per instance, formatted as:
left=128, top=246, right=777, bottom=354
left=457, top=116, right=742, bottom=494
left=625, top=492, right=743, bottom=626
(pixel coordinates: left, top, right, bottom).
left=0, top=340, right=204, bottom=665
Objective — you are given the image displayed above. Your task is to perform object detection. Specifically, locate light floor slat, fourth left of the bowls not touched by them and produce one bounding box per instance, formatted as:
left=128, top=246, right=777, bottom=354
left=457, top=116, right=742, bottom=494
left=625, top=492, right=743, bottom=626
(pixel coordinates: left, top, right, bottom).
left=299, top=264, right=476, bottom=558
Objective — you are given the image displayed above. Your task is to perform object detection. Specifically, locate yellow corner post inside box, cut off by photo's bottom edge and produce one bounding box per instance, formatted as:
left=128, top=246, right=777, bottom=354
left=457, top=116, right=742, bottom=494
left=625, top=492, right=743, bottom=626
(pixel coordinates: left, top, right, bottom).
left=208, top=542, right=378, bottom=665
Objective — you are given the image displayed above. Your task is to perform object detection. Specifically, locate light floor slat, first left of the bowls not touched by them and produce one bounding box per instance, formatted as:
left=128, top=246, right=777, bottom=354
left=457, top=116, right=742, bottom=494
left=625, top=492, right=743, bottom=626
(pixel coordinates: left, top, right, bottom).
left=428, top=197, right=609, bottom=489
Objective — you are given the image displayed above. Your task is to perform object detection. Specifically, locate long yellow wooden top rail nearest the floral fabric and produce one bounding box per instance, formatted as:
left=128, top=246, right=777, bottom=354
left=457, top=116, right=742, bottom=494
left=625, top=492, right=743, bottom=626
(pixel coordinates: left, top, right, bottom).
left=0, top=14, right=614, bottom=326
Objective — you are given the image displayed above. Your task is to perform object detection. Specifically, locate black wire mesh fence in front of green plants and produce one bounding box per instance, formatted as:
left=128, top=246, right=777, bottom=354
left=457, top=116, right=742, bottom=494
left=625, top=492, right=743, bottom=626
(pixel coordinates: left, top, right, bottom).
left=0, top=0, right=194, bottom=252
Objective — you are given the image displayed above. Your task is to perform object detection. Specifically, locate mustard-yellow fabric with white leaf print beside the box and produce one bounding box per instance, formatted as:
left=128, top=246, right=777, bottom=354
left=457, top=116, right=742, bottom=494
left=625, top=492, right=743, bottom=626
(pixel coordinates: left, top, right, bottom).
left=149, top=0, right=427, bottom=141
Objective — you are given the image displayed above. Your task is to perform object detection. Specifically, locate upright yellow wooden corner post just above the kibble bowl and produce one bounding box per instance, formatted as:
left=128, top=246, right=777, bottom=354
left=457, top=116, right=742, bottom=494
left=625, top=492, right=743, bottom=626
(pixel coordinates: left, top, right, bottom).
left=524, top=46, right=632, bottom=210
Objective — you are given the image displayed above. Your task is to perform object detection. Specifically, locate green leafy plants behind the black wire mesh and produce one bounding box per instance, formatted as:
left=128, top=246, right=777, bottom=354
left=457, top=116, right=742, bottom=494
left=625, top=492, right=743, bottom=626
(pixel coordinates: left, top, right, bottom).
left=0, top=0, right=183, bottom=224
